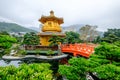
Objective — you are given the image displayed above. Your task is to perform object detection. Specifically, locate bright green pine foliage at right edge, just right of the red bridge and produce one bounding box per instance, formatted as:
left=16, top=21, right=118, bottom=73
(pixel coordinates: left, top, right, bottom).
left=95, top=43, right=120, bottom=61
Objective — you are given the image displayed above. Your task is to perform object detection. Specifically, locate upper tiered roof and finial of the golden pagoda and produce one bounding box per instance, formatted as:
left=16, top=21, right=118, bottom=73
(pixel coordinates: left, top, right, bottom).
left=39, top=11, right=64, bottom=24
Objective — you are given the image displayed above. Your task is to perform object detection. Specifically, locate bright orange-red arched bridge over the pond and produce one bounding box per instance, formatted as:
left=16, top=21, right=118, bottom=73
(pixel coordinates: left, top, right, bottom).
left=61, top=44, right=95, bottom=58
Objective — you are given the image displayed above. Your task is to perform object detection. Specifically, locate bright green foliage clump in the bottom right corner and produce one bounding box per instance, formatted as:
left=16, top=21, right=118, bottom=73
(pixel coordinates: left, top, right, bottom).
left=94, top=64, right=120, bottom=80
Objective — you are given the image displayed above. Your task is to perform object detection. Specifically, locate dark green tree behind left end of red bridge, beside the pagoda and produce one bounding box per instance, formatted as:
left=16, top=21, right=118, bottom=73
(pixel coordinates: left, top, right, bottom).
left=65, top=31, right=81, bottom=44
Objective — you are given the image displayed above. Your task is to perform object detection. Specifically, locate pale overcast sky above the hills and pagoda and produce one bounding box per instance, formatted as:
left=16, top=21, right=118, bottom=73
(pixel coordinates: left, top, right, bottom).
left=0, top=0, right=120, bottom=31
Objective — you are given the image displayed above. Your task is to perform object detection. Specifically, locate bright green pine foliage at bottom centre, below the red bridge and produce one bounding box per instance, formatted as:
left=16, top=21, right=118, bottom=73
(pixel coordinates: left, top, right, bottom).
left=59, top=58, right=88, bottom=80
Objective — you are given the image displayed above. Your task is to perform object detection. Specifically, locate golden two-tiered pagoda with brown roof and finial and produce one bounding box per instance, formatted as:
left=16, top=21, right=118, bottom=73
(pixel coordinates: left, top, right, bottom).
left=39, top=11, right=65, bottom=46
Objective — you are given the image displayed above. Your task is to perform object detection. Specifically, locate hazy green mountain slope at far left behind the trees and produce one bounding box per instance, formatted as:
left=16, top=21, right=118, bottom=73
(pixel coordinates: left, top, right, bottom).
left=0, top=22, right=36, bottom=32
